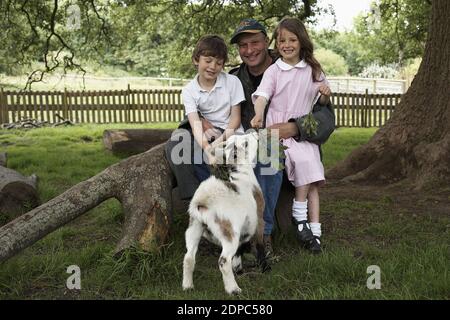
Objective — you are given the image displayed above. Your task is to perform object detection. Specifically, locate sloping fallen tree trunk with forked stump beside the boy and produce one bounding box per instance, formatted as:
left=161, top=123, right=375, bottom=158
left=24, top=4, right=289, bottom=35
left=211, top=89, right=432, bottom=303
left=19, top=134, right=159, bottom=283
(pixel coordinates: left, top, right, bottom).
left=0, top=144, right=173, bottom=261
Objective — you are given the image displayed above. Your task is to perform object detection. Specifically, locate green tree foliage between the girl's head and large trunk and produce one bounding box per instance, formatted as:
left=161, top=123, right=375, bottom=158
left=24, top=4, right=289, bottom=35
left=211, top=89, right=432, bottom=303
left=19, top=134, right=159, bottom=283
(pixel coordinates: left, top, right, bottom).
left=313, top=0, right=431, bottom=75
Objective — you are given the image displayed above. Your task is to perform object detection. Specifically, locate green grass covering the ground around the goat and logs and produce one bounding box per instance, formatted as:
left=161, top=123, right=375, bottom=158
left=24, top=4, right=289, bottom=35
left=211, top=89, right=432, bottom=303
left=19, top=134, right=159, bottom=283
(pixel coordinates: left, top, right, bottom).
left=0, top=124, right=450, bottom=300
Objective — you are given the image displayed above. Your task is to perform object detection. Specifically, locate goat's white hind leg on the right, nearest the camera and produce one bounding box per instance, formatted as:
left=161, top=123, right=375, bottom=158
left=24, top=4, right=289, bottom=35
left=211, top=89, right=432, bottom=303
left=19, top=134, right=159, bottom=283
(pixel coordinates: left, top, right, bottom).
left=219, top=239, right=241, bottom=294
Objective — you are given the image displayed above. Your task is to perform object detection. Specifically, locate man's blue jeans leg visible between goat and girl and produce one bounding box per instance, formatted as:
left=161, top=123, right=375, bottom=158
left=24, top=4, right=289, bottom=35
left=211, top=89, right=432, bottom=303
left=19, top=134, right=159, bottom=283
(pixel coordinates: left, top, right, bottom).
left=254, top=162, right=283, bottom=235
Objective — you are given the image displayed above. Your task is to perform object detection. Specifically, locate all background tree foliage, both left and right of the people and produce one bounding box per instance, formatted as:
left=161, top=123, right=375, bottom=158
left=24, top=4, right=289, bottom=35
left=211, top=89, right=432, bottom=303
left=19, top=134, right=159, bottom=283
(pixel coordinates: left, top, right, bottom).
left=0, top=0, right=430, bottom=84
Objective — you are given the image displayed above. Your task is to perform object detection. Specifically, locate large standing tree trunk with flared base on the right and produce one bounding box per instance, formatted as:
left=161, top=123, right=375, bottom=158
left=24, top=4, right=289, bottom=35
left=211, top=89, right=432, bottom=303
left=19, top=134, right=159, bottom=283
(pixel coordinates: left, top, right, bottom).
left=327, top=0, right=450, bottom=189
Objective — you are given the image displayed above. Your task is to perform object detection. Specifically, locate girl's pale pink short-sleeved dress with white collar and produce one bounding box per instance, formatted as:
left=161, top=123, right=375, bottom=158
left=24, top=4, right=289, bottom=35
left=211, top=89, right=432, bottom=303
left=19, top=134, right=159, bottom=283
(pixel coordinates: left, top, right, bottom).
left=252, top=59, right=328, bottom=187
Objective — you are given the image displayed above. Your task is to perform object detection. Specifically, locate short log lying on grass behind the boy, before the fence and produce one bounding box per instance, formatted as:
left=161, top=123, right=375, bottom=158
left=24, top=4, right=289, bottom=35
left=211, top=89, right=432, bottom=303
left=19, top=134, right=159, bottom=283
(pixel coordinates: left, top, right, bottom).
left=103, top=129, right=173, bottom=154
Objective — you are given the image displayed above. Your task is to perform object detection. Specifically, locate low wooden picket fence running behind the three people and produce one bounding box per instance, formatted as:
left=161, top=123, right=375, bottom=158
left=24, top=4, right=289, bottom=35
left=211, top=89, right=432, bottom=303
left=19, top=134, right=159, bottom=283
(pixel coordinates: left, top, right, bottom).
left=0, top=89, right=401, bottom=127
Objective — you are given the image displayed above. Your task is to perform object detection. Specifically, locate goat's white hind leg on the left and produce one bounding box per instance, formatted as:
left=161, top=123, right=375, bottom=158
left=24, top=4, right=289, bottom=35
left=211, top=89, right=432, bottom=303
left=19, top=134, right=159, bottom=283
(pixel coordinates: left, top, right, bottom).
left=183, top=217, right=203, bottom=290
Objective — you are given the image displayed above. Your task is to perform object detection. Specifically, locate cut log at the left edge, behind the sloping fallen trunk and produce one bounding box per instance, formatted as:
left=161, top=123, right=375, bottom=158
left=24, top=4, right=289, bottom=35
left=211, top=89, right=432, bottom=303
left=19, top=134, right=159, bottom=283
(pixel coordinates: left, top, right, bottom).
left=0, top=153, right=39, bottom=226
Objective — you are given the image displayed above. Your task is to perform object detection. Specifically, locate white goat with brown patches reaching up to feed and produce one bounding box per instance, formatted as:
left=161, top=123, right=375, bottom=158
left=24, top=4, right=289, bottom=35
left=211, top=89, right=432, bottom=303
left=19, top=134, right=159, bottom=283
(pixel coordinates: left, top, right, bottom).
left=183, top=132, right=270, bottom=294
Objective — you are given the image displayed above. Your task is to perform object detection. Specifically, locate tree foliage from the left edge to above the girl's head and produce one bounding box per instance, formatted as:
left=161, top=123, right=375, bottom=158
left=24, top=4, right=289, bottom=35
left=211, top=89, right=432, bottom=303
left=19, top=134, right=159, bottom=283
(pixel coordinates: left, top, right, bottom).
left=0, top=0, right=330, bottom=84
